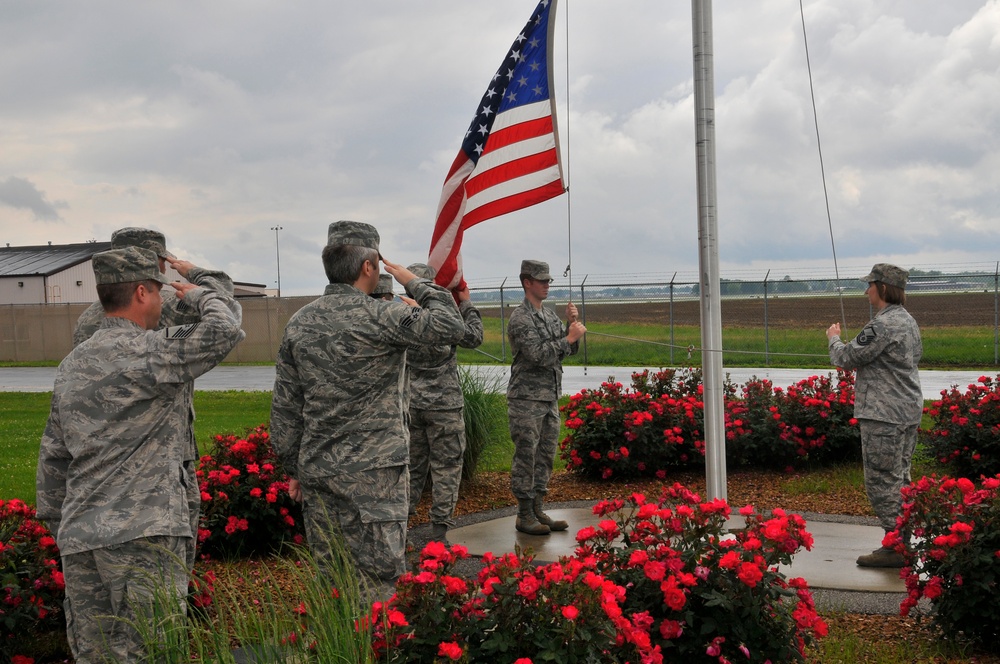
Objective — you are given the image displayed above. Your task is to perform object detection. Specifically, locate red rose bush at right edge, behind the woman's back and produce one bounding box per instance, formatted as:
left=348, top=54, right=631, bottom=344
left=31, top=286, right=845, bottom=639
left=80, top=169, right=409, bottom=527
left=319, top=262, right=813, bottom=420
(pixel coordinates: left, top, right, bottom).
left=924, top=376, right=1000, bottom=477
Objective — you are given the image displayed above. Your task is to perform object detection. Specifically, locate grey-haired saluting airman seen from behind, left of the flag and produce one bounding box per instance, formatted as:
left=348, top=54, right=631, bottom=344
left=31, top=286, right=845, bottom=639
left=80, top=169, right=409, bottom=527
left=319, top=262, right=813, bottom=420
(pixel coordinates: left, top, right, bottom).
left=271, top=221, right=465, bottom=597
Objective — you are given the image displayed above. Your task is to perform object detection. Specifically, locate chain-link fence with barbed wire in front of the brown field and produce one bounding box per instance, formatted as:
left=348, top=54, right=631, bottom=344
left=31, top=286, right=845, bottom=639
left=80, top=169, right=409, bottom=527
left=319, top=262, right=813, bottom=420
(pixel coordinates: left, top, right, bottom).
left=464, top=272, right=1000, bottom=367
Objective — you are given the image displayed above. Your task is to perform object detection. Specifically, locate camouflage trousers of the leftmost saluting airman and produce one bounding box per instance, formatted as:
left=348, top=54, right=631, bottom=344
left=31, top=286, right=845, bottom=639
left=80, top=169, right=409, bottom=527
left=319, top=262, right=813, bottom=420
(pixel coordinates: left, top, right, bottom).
left=62, top=536, right=191, bottom=664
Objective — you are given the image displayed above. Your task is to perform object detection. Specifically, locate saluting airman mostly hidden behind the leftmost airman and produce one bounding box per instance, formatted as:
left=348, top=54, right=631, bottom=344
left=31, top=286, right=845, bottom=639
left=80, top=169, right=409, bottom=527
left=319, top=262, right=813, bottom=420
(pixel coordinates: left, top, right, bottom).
left=73, top=226, right=233, bottom=570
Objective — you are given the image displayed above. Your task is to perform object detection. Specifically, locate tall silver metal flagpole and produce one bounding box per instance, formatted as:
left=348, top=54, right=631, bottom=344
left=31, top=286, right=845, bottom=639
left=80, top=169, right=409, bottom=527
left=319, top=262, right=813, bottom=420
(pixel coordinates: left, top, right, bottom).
left=691, top=0, right=728, bottom=500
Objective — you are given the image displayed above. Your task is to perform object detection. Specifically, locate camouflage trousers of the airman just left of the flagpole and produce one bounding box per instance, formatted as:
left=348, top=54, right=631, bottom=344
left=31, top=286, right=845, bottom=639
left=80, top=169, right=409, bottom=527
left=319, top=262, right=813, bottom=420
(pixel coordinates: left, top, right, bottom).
left=507, top=399, right=560, bottom=500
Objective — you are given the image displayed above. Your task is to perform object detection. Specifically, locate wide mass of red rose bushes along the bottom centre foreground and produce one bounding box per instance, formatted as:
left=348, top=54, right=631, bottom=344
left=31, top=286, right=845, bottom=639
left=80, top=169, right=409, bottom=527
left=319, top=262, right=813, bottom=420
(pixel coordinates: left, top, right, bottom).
left=369, top=485, right=827, bottom=664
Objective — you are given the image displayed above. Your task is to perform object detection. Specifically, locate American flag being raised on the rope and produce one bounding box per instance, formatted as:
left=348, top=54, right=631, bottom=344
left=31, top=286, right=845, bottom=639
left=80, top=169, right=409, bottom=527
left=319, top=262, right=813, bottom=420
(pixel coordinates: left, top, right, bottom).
left=427, top=0, right=566, bottom=288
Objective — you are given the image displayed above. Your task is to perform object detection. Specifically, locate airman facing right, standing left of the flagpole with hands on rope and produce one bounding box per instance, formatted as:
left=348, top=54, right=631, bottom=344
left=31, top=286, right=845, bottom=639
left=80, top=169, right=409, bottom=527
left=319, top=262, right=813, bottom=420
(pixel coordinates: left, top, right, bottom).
left=507, top=260, right=587, bottom=535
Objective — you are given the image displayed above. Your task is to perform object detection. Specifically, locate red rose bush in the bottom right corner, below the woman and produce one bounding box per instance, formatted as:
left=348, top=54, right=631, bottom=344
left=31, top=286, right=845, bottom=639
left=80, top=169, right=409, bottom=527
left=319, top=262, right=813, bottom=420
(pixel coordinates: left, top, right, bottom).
left=885, top=475, right=1000, bottom=653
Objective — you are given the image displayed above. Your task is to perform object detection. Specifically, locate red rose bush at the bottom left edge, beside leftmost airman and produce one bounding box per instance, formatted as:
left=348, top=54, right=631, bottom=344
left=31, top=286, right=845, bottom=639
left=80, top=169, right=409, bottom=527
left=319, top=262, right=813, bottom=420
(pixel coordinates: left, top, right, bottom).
left=0, top=499, right=66, bottom=663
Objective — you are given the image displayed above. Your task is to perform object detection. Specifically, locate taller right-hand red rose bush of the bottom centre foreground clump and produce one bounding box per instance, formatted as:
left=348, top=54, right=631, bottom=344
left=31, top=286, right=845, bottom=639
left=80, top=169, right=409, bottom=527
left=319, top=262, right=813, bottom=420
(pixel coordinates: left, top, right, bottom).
left=576, top=484, right=827, bottom=664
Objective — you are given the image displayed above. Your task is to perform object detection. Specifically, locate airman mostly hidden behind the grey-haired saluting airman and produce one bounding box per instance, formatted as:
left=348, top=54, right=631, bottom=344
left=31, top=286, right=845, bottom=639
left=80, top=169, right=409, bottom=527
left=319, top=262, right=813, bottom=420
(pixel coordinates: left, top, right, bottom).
left=406, top=263, right=483, bottom=542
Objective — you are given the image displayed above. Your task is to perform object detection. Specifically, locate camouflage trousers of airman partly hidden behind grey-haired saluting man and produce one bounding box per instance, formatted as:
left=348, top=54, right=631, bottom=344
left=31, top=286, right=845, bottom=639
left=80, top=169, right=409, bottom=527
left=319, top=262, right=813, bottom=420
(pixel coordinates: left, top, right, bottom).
left=410, top=408, right=465, bottom=528
